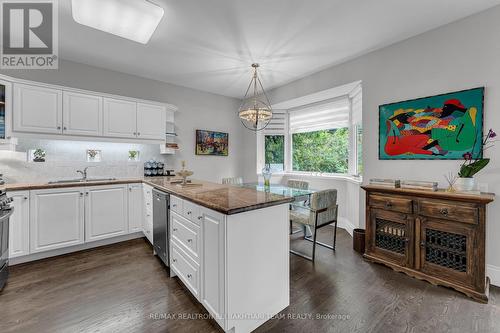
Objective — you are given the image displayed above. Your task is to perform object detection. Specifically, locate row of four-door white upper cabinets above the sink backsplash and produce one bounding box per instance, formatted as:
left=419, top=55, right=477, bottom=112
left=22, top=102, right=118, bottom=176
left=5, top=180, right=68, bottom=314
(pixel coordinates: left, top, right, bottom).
left=8, top=81, right=175, bottom=142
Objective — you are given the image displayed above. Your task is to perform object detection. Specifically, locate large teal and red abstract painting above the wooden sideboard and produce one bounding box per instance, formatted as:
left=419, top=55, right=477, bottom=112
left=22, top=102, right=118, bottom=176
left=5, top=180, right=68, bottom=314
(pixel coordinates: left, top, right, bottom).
left=379, top=88, right=484, bottom=160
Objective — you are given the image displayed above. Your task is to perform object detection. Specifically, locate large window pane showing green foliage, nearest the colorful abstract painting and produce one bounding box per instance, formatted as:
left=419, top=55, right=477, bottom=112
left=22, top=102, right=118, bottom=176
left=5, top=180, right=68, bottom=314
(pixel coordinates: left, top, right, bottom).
left=292, top=128, right=349, bottom=173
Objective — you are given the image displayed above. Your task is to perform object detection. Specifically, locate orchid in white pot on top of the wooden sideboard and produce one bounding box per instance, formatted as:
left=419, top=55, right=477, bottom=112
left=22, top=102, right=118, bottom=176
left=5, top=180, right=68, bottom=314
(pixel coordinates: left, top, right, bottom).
left=454, top=129, right=497, bottom=191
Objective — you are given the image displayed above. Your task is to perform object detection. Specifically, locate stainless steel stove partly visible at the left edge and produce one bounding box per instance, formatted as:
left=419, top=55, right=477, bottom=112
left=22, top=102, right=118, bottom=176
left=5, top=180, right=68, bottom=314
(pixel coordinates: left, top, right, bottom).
left=0, top=187, right=14, bottom=290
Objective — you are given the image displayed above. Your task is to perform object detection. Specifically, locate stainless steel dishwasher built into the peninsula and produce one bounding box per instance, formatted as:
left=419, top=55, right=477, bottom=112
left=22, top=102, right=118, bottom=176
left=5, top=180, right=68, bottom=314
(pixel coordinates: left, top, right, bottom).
left=153, top=189, right=170, bottom=267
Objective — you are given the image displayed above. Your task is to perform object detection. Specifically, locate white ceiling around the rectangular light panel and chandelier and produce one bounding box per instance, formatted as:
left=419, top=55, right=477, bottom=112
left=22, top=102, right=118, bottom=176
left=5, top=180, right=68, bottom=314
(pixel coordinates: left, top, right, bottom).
left=59, top=0, right=500, bottom=97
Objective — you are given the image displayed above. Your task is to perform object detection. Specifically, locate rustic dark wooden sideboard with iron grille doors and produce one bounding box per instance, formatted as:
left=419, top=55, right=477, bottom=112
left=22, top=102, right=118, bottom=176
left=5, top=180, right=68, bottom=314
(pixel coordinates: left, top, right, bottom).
left=362, top=185, right=495, bottom=302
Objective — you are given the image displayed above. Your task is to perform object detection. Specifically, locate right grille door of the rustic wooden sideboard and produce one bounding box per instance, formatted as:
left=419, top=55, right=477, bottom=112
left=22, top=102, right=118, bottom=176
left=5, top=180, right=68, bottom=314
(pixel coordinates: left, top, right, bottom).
left=419, top=218, right=476, bottom=288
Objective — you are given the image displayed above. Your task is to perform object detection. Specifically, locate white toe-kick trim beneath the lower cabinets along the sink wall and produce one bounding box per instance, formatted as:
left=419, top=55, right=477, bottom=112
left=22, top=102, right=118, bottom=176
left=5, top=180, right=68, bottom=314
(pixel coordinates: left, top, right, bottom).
left=9, top=231, right=144, bottom=266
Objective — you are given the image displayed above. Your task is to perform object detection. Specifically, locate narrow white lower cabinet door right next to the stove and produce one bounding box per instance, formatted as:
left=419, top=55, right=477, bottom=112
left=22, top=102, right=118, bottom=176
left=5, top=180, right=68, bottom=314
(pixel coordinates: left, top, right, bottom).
left=7, top=191, right=30, bottom=258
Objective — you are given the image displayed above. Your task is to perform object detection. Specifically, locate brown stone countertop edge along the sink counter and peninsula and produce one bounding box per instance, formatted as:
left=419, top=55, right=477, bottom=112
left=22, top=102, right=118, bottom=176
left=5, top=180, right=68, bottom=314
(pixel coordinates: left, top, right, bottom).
left=3, top=178, right=293, bottom=215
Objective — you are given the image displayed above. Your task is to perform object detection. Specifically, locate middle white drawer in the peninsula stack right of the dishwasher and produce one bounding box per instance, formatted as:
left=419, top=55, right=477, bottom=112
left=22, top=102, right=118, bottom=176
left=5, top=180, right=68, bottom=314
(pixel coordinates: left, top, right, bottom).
left=171, top=213, right=200, bottom=263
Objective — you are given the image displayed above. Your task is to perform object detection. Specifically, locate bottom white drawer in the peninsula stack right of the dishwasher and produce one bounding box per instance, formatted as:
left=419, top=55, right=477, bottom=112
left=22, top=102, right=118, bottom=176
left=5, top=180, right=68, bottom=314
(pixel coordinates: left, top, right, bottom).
left=171, top=242, right=200, bottom=299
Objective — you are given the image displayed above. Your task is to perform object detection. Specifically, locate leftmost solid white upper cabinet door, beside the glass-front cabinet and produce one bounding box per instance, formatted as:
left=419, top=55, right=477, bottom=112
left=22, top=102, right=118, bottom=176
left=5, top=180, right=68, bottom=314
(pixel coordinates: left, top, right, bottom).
left=13, top=84, right=62, bottom=134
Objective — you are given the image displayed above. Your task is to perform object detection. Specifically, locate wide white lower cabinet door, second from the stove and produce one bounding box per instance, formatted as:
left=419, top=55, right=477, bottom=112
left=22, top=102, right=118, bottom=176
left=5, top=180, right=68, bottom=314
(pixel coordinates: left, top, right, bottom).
left=30, top=187, right=84, bottom=253
